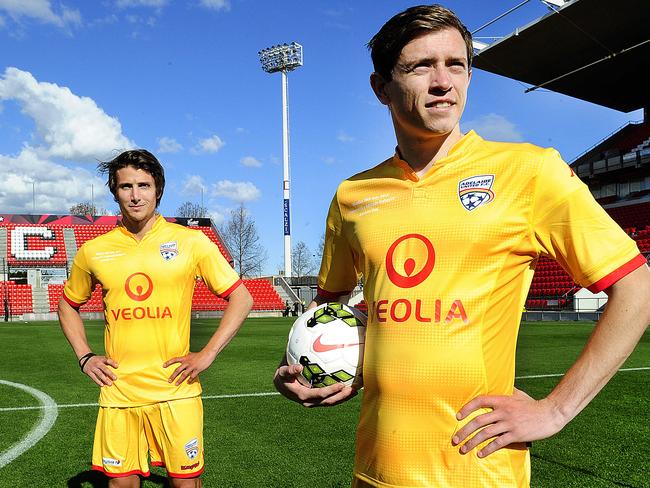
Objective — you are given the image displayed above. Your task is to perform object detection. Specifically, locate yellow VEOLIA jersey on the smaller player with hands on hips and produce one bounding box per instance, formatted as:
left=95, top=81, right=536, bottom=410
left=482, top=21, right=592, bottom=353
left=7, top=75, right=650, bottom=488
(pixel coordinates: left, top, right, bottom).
left=63, top=216, right=241, bottom=407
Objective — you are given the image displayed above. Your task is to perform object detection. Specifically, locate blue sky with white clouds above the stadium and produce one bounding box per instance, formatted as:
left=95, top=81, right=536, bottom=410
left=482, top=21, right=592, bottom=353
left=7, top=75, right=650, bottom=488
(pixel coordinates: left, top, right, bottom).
left=0, top=0, right=642, bottom=273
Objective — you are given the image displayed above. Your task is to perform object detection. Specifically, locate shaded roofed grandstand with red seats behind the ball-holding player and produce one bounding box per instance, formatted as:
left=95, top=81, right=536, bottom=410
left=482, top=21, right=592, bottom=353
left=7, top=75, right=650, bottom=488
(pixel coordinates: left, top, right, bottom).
left=472, top=0, right=650, bottom=320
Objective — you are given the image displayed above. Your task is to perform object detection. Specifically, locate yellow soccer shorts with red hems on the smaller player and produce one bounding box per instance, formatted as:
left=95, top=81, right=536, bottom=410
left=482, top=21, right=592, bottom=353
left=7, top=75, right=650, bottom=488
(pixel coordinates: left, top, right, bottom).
left=92, top=396, right=203, bottom=478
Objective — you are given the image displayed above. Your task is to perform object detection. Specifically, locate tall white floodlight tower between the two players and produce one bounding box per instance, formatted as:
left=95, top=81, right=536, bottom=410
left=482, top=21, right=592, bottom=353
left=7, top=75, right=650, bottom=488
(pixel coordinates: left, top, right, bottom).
left=257, top=42, right=302, bottom=276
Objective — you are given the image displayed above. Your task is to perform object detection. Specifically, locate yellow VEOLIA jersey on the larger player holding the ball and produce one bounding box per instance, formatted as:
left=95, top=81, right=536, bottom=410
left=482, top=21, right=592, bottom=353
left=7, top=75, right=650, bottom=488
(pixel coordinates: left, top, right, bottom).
left=319, top=132, right=645, bottom=488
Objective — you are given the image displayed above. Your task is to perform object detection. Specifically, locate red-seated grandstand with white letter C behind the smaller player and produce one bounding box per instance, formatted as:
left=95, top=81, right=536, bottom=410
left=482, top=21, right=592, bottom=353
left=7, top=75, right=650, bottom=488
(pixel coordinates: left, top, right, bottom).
left=0, top=214, right=288, bottom=321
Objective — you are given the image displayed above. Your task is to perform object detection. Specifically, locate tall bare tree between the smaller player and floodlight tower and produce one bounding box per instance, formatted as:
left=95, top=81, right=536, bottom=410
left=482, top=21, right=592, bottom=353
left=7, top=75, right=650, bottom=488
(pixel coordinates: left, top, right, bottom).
left=219, top=203, right=267, bottom=278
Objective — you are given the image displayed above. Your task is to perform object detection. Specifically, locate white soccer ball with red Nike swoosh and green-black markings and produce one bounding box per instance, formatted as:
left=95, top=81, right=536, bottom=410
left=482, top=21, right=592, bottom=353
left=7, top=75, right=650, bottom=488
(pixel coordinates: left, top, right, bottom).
left=287, top=302, right=367, bottom=388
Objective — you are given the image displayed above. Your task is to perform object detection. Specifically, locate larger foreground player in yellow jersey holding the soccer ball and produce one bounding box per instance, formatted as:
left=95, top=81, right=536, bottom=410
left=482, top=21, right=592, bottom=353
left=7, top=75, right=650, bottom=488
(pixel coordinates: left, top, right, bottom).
left=274, top=5, right=650, bottom=488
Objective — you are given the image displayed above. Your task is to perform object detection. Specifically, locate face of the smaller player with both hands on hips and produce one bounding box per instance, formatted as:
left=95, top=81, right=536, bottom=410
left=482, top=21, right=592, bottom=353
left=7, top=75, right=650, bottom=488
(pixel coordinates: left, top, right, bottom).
left=115, top=166, right=156, bottom=223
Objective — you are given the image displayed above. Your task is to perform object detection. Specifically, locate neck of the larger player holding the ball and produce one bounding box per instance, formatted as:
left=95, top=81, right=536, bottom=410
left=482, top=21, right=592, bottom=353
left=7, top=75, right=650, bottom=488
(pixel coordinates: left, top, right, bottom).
left=396, top=126, right=463, bottom=177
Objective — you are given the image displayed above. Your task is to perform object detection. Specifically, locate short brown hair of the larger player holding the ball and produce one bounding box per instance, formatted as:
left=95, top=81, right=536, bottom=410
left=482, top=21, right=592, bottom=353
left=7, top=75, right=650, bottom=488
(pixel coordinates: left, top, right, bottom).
left=368, top=4, right=474, bottom=81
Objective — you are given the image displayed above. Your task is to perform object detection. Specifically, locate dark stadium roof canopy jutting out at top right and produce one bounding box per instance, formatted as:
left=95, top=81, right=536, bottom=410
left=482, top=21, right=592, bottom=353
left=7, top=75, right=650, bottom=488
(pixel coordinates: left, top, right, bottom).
left=473, top=0, right=650, bottom=112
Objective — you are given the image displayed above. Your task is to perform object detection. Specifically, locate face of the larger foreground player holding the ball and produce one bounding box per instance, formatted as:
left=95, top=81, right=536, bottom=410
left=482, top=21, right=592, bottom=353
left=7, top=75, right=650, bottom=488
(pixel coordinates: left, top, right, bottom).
left=372, top=28, right=471, bottom=138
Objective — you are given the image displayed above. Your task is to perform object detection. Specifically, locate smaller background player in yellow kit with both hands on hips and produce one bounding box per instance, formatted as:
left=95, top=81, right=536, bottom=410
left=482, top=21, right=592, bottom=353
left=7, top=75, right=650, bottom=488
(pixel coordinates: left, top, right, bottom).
left=59, top=150, right=252, bottom=488
